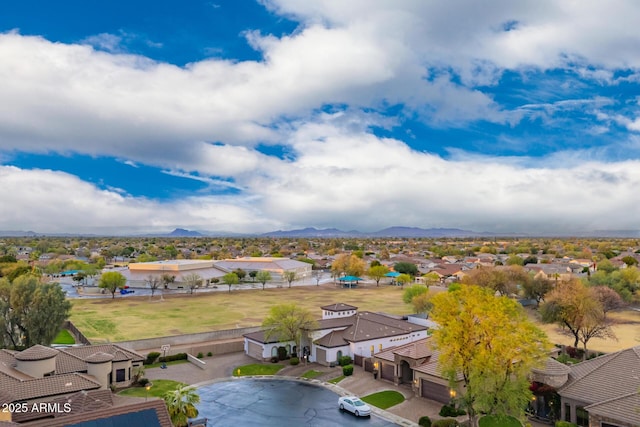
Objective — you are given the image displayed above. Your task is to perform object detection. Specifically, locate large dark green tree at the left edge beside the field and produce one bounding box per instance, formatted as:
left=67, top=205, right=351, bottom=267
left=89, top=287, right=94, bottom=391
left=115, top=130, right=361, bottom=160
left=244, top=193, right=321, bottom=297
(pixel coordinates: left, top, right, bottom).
left=0, top=275, right=71, bottom=348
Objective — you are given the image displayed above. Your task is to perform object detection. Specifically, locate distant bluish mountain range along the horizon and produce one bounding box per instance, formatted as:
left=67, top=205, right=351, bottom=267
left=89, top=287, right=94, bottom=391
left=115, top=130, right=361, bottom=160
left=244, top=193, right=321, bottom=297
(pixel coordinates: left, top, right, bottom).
left=0, top=226, right=640, bottom=238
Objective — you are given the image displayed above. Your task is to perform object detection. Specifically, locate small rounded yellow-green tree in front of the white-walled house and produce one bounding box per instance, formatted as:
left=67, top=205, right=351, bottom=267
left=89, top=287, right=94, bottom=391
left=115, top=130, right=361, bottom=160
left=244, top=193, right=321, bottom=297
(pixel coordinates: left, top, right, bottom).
left=262, top=304, right=317, bottom=362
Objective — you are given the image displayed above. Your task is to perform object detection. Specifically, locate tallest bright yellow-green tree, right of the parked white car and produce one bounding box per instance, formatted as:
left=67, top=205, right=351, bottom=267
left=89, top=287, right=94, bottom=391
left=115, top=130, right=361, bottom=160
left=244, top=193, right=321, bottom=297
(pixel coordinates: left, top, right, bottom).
left=431, top=285, right=550, bottom=427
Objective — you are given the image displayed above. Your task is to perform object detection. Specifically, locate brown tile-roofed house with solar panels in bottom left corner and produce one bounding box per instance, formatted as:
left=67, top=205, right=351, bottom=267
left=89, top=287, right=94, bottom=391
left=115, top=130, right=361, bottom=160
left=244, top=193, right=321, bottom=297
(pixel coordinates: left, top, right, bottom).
left=0, top=344, right=172, bottom=427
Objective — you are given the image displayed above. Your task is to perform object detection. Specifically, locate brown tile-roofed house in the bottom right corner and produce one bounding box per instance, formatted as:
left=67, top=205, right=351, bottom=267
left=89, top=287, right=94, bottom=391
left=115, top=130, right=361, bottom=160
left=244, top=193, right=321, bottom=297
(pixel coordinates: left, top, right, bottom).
left=558, top=346, right=640, bottom=427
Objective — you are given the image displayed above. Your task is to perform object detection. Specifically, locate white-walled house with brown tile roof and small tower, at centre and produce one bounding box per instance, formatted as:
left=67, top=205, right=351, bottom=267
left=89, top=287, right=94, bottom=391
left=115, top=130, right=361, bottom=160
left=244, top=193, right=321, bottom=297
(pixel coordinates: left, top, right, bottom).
left=244, top=303, right=428, bottom=370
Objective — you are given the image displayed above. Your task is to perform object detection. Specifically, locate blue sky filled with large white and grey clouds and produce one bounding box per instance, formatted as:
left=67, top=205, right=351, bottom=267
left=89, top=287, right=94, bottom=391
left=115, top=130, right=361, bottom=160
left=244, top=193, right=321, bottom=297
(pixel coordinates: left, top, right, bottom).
left=0, top=0, right=640, bottom=234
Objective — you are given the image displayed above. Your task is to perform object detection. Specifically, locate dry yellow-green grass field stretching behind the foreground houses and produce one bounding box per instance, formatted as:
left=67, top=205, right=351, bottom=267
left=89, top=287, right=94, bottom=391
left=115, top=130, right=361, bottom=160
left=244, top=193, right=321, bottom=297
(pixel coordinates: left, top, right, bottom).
left=71, top=284, right=640, bottom=352
